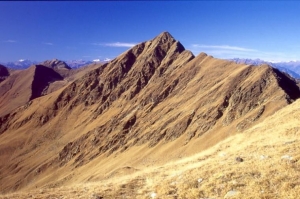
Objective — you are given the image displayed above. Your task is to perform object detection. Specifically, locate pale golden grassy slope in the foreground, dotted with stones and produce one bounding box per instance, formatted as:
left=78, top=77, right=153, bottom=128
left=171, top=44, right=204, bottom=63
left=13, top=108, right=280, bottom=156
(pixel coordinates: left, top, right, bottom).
left=0, top=95, right=300, bottom=198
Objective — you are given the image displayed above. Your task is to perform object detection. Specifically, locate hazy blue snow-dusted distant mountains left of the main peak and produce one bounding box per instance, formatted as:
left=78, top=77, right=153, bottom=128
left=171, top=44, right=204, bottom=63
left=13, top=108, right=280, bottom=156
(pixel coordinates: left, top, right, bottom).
left=0, top=59, right=103, bottom=70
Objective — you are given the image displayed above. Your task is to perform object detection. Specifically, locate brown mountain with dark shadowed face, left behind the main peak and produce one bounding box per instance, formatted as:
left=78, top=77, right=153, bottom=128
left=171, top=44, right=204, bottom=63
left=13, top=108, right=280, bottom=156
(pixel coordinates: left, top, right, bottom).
left=0, top=59, right=101, bottom=116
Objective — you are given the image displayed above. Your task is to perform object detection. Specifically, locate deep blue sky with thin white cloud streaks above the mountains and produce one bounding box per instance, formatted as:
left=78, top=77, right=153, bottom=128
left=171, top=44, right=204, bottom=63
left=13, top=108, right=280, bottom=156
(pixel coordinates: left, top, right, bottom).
left=0, top=1, right=300, bottom=61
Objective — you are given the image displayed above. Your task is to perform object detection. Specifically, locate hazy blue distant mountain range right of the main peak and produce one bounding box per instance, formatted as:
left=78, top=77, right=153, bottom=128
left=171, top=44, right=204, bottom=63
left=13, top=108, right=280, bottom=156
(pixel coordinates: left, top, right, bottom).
left=229, top=58, right=300, bottom=79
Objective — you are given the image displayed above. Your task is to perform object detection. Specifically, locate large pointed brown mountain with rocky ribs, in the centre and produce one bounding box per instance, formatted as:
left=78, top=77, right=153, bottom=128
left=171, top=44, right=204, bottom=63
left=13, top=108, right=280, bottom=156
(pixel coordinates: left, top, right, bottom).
left=0, top=32, right=300, bottom=192
